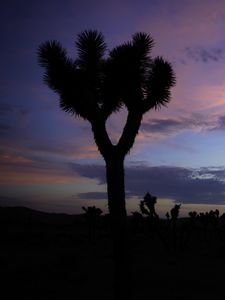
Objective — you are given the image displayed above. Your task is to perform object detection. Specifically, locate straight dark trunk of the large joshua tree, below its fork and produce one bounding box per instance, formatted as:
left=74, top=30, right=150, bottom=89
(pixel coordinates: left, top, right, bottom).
left=106, top=154, right=129, bottom=299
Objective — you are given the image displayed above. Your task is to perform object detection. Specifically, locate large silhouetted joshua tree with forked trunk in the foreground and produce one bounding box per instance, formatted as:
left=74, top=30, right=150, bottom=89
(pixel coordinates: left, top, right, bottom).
left=38, top=30, right=175, bottom=298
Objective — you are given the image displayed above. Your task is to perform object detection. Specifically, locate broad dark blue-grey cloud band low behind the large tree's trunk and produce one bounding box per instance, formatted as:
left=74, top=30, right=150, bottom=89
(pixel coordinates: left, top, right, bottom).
left=72, top=164, right=225, bottom=204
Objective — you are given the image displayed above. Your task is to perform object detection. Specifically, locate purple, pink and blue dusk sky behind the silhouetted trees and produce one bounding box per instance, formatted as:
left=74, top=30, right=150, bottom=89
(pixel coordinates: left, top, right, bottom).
left=0, top=0, right=225, bottom=216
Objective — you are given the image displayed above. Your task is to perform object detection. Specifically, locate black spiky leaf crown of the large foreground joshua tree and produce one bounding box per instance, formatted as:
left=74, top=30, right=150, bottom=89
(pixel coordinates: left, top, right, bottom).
left=38, top=30, right=175, bottom=121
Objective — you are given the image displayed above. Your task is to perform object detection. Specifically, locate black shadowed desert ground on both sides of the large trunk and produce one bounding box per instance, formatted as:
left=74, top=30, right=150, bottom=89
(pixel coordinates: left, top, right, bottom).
left=0, top=207, right=225, bottom=300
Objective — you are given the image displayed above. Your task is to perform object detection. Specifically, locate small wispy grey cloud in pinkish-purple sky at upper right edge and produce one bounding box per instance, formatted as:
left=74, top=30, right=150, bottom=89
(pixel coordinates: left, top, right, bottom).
left=184, top=47, right=225, bottom=63
